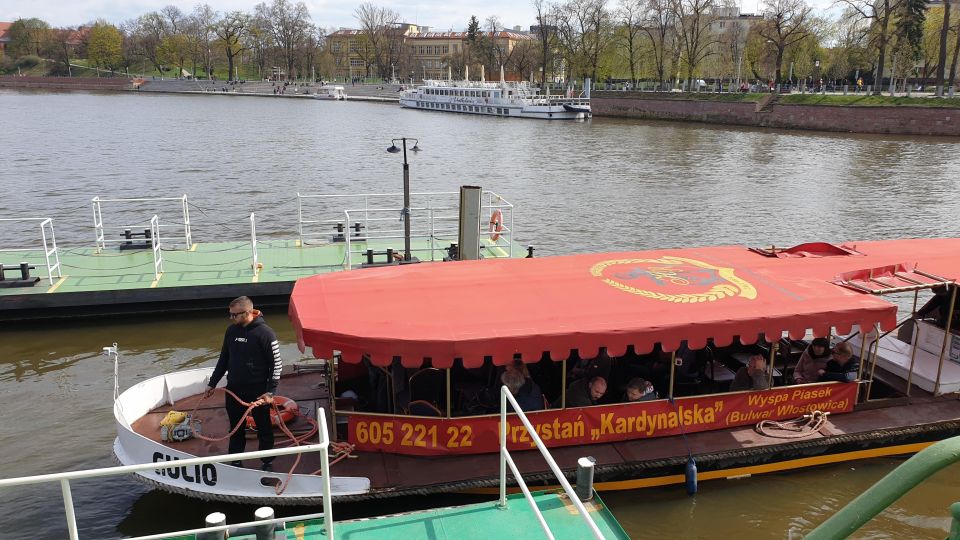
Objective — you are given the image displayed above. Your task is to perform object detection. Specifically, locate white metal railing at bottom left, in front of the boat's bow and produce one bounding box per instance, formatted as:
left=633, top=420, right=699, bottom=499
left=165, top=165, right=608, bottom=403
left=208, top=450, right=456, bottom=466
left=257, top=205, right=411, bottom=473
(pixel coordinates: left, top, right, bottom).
left=0, top=408, right=334, bottom=540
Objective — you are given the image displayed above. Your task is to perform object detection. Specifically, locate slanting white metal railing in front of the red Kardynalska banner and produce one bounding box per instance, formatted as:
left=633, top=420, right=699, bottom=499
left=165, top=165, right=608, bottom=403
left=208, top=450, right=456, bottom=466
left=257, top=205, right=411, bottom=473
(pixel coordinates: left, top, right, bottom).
left=500, top=386, right=603, bottom=540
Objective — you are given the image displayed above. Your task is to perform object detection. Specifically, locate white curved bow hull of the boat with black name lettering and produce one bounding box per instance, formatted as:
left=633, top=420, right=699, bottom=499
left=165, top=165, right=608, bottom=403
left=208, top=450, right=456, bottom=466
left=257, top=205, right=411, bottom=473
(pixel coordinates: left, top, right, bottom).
left=113, top=368, right=370, bottom=504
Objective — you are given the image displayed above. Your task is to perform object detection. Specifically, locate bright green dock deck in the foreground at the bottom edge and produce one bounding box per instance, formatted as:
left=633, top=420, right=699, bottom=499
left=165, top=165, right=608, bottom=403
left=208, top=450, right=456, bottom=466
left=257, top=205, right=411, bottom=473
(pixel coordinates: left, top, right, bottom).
left=170, top=491, right=629, bottom=540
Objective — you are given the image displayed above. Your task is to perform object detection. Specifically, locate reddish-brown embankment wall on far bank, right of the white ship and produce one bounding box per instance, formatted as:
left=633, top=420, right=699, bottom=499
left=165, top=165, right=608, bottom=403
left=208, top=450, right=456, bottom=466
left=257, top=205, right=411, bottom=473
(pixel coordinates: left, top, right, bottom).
left=591, top=92, right=960, bottom=137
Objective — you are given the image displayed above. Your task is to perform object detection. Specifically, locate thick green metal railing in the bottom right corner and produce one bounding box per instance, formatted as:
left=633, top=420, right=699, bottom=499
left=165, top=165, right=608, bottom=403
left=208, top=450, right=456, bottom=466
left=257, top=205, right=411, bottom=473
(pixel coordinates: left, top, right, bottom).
left=806, top=437, right=960, bottom=540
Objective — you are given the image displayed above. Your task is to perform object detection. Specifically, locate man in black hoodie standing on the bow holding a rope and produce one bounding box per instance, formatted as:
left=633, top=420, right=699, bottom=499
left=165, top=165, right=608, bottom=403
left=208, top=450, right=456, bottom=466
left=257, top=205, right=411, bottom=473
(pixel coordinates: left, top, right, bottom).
left=204, top=296, right=283, bottom=471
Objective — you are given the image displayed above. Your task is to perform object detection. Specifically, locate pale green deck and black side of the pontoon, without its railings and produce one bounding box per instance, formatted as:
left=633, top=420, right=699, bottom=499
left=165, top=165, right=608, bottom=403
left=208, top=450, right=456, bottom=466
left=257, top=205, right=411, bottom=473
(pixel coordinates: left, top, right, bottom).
left=0, top=237, right=510, bottom=321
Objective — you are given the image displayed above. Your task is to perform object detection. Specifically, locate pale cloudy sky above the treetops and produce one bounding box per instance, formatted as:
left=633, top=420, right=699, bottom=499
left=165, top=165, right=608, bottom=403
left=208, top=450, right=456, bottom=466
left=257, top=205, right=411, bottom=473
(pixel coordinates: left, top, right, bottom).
left=0, top=0, right=832, bottom=31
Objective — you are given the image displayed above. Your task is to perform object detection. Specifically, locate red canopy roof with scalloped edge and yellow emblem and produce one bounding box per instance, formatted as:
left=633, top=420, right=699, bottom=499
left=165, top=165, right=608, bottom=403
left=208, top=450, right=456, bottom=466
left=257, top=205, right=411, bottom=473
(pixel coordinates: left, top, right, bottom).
left=290, top=239, right=960, bottom=368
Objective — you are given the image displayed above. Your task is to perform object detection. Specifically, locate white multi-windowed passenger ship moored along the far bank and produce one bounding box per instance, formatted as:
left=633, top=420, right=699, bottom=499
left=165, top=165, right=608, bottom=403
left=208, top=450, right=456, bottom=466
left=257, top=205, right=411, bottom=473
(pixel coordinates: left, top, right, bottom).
left=400, top=79, right=592, bottom=120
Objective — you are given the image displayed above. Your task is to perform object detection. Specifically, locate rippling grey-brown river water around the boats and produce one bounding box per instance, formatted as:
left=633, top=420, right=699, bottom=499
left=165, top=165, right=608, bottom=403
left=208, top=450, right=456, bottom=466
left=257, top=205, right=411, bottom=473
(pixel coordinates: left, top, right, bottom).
left=0, top=91, right=960, bottom=539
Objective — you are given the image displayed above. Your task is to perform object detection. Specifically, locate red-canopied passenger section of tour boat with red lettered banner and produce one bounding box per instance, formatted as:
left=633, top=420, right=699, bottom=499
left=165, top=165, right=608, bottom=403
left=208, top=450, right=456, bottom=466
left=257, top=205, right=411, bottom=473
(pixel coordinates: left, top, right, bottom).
left=116, top=238, right=960, bottom=499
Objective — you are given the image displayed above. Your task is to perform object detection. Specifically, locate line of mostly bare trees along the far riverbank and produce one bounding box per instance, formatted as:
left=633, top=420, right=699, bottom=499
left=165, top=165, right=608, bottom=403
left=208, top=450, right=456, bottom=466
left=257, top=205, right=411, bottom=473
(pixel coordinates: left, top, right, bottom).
left=2, top=0, right=960, bottom=94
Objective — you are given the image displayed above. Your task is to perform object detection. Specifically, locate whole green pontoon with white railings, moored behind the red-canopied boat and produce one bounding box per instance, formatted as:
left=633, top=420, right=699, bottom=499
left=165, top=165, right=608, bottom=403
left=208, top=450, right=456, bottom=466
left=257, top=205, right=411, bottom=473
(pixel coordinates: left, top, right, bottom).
left=0, top=188, right=527, bottom=321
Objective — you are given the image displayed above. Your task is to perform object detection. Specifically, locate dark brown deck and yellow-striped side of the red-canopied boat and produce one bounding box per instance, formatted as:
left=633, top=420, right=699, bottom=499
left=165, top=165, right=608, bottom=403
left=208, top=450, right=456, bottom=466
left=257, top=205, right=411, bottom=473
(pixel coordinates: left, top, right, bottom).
left=133, top=373, right=960, bottom=500
